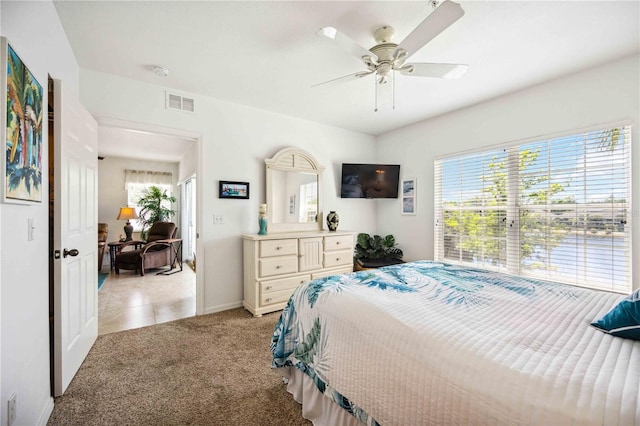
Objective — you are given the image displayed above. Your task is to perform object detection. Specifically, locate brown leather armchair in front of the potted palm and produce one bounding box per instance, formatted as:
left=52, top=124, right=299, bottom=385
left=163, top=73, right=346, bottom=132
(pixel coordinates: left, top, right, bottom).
left=115, top=222, right=178, bottom=276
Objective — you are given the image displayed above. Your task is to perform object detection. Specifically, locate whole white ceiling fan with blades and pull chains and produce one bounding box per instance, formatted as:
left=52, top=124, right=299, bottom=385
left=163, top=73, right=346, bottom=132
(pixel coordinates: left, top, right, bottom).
left=313, top=0, right=468, bottom=111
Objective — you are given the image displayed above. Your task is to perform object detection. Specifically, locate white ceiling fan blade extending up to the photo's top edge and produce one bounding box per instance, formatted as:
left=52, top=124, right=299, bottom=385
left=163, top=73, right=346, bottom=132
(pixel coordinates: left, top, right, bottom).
left=398, top=0, right=464, bottom=58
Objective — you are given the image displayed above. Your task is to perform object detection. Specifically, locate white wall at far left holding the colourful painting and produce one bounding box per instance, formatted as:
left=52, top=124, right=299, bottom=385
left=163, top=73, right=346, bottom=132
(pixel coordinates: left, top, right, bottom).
left=0, top=0, right=79, bottom=425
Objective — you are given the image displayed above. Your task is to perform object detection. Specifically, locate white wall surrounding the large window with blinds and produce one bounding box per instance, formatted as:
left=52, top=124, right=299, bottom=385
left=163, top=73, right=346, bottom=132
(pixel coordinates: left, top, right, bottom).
left=377, top=55, right=640, bottom=288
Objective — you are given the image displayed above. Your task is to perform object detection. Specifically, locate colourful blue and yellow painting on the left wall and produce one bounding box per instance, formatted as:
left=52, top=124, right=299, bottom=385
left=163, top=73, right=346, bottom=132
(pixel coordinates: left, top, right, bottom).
left=0, top=37, right=44, bottom=204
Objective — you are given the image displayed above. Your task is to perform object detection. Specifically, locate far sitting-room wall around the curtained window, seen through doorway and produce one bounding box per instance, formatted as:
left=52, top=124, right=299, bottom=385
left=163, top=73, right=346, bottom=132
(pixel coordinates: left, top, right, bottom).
left=98, top=157, right=180, bottom=246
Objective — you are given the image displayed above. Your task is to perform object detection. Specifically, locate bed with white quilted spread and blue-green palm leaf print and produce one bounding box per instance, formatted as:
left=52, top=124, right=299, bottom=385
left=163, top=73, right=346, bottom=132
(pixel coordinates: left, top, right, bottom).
left=271, top=261, right=640, bottom=426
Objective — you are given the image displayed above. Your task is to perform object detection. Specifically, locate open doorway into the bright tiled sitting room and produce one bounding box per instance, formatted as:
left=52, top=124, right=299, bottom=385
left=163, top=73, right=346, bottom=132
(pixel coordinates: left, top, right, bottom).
left=93, top=118, right=201, bottom=335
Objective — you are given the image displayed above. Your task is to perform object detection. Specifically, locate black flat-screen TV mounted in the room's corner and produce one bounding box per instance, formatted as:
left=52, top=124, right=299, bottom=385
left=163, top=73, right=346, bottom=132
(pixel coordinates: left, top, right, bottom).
left=340, top=163, right=400, bottom=198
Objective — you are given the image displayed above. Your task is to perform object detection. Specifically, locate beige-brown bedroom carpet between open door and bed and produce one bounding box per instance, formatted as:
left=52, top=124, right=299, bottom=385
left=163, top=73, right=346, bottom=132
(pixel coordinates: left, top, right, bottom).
left=48, top=309, right=311, bottom=425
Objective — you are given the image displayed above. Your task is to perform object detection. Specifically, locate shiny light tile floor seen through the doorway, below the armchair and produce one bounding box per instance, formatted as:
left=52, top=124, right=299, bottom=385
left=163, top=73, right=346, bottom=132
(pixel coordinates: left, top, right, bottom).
left=98, top=264, right=196, bottom=334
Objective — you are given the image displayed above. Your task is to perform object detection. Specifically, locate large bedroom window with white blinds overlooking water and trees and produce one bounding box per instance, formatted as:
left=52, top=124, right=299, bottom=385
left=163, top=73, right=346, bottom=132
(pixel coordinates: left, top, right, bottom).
left=434, top=127, right=631, bottom=293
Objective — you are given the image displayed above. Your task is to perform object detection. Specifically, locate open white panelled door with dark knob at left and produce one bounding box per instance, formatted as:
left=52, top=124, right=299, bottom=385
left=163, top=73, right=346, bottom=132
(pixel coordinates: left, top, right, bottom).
left=53, top=80, right=98, bottom=396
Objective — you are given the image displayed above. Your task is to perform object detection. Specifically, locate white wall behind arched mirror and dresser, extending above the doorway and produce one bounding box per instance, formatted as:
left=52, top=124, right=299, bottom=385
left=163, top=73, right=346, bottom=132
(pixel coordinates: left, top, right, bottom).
left=80, top=69, right=376, bottom=312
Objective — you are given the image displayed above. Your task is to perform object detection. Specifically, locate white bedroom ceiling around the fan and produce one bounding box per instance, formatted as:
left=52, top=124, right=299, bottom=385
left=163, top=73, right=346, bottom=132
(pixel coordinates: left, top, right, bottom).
left=54, top=0, right=640, bottom=160
